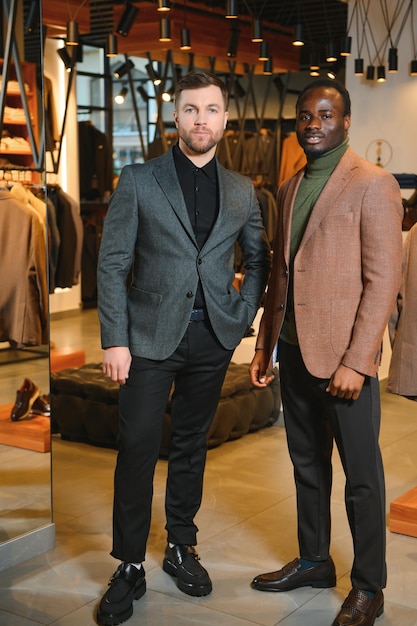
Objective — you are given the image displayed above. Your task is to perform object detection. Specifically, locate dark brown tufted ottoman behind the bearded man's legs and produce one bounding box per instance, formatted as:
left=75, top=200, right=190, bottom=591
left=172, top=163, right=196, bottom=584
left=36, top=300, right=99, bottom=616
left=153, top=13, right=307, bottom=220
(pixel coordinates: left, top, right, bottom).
left=51, top=363, right=281, bottom=456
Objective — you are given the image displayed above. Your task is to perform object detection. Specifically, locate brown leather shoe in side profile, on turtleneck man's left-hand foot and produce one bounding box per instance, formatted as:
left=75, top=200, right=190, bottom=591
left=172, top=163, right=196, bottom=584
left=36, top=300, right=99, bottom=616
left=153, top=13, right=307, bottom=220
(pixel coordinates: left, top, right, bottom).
left=252, top=557, right=336, bottom=591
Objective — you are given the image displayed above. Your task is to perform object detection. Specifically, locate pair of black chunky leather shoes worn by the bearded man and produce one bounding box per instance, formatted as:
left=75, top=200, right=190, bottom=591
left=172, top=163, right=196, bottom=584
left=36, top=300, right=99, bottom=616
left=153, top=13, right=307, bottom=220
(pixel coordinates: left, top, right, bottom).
left=96, top=545, right=212, bottom=626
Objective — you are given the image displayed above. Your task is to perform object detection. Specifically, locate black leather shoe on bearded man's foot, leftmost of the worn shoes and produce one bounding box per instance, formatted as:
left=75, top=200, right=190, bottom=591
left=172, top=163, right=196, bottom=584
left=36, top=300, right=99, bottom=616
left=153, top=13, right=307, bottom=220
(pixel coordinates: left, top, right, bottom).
left=97, top=563, right=146, bottom=626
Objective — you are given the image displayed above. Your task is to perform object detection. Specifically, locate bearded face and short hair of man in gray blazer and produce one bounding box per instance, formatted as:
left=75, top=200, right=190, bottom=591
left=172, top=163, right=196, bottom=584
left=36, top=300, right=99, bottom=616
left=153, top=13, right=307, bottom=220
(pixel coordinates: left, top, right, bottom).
left=174, top=85, right=228, bottom=155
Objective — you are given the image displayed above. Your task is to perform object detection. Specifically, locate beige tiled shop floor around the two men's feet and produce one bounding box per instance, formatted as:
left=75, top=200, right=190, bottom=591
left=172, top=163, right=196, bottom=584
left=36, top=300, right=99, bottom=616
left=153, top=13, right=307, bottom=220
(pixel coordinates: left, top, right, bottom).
left=0, top=310, right=417, bottom=626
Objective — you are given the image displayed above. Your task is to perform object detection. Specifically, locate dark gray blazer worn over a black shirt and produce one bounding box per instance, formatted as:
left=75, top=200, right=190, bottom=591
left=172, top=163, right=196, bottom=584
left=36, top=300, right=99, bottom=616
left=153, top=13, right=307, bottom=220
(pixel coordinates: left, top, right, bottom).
left=97, top=150, right=270, bottom=360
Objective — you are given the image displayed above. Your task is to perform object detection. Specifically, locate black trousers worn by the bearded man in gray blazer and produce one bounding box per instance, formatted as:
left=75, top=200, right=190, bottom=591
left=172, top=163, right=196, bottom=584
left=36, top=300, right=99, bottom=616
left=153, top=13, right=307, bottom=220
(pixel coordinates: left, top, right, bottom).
left=111, top=321, right=233, bottom=563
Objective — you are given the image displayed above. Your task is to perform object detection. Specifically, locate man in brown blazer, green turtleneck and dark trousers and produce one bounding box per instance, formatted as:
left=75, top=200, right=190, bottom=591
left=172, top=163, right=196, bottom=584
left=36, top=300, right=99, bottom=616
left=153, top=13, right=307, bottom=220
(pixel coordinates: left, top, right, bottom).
left=250, top=80, right=403, bottom=626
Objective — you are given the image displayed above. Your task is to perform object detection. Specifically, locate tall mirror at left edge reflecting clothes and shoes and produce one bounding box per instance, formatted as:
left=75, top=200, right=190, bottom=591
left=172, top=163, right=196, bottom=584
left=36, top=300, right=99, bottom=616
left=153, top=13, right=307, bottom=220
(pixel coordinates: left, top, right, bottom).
left=0, top=0, right=52, bottom=569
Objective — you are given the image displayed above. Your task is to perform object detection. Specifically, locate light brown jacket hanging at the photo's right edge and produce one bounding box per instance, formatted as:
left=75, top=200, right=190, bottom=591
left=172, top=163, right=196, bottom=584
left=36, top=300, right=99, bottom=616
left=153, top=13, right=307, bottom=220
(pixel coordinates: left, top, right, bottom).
left=387, top=224, right=417, bottom=400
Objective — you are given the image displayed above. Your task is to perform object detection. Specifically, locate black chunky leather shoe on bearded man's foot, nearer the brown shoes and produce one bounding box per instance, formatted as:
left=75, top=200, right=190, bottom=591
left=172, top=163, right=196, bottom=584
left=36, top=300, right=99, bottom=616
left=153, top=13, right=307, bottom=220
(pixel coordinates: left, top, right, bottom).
left=162, top=545, right=212, bottom=597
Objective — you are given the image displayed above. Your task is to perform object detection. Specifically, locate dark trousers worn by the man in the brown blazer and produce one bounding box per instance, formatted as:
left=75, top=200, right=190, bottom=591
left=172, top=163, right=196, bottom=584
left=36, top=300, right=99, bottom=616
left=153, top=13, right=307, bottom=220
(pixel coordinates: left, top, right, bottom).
left=278, top=341, right=386, bottom=591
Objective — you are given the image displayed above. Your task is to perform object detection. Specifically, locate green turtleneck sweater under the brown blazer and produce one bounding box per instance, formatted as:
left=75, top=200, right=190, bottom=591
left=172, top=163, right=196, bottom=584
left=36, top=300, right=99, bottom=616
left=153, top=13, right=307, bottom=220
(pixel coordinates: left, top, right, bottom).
left=280, top=138, right=349, bottom=345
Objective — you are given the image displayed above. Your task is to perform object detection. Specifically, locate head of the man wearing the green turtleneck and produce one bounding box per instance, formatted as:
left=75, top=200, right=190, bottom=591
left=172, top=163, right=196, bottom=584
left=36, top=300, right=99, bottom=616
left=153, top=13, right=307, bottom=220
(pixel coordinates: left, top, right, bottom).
left=296, top=87, right=350, bottom=157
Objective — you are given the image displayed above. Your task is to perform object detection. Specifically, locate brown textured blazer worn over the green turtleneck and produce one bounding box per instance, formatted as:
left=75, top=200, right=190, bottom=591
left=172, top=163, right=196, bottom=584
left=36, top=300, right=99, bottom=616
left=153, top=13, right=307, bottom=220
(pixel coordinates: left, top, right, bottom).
left=256, top=148, right=403, bottom=378
